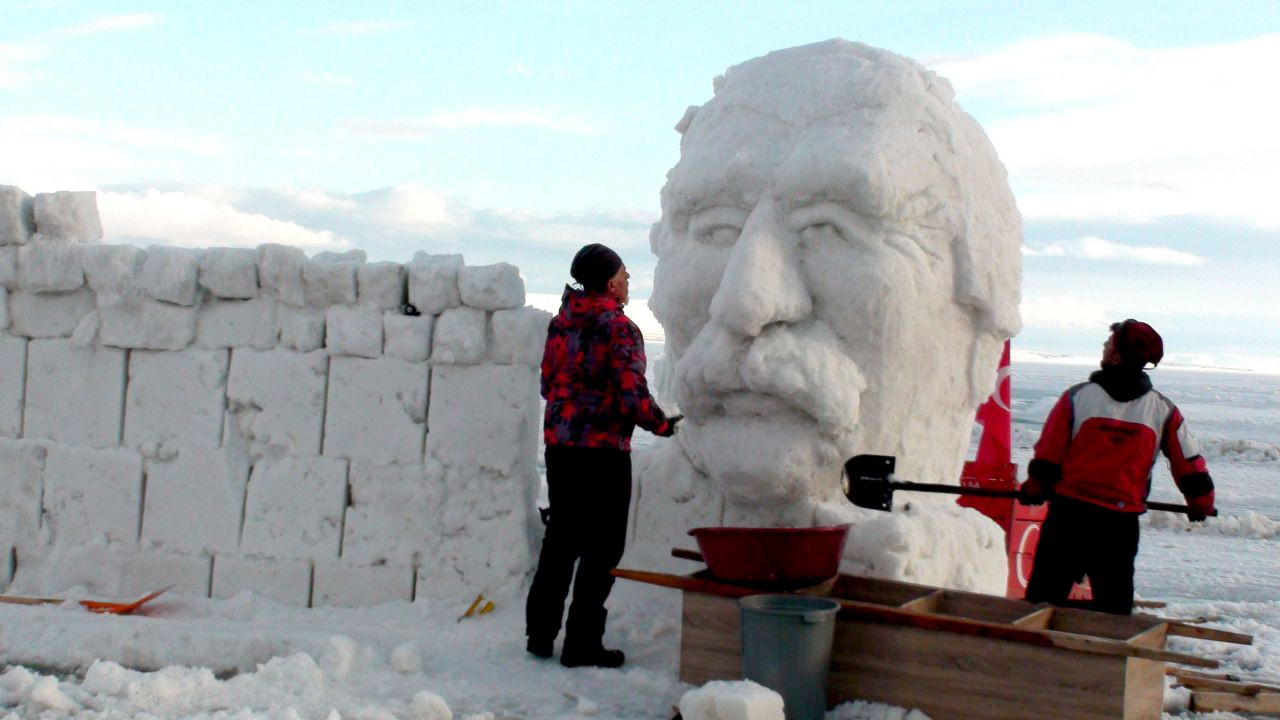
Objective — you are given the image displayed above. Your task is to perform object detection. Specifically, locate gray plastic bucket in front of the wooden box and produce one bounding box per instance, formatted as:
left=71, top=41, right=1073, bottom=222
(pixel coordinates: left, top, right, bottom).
left=739, top=594, right=840, bottom=720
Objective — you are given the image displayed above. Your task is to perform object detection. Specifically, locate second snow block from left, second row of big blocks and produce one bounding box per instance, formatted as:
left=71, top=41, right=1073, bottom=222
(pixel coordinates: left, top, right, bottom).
left=44, top=443, right=142, bottom=550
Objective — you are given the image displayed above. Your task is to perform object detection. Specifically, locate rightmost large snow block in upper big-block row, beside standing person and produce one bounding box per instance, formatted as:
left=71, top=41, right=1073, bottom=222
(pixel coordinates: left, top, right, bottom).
left=426, top=365, right=541, bottom=475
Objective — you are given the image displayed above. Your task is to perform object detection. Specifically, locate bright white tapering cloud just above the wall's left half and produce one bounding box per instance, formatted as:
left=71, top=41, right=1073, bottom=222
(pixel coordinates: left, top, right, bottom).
left=97, top=190, right=352, bottom=252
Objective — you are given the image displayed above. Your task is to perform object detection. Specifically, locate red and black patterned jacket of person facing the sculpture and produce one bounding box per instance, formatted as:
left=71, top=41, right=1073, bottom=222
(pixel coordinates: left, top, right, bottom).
left=541, top=286, right=667, bottom=450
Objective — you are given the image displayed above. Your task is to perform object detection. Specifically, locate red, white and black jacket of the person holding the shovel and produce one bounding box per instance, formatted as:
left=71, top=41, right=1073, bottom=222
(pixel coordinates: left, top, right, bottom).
left=1028, top=368, right=1213, bottom=512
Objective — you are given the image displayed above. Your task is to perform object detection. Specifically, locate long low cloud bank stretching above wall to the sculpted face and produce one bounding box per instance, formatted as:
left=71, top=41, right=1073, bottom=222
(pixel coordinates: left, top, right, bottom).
left=99, top=183, right=654, bottom=274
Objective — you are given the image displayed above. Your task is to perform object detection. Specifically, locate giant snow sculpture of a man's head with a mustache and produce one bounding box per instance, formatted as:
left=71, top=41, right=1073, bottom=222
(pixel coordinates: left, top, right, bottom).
left=650, top=41, right=1021, bottom=509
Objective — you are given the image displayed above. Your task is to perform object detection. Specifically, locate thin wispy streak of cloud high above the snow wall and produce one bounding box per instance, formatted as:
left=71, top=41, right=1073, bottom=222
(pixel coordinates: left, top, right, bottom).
left=342, top=108, right=600, bottom=140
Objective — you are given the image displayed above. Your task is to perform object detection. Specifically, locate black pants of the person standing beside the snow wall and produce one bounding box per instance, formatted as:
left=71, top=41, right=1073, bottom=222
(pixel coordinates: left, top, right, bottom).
left=525, top=445, right=631, bottom=652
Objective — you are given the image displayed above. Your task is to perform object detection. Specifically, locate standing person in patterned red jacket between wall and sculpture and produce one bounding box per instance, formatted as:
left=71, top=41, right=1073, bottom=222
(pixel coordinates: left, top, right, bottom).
left=525, top=243, right=681, bottom=667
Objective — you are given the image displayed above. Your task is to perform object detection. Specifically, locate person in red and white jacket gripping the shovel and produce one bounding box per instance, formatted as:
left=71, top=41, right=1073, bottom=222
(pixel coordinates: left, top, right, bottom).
left=1020, top=319, right=1216, bottom=615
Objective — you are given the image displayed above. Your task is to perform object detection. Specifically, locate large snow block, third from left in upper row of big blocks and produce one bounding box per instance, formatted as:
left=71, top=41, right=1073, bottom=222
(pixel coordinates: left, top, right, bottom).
left=124, top=348, right=230, bottom=456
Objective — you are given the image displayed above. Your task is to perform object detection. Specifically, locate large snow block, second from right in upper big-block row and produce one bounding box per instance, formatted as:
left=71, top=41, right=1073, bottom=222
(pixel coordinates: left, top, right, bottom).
left=323, top=357, right=430, bottom=465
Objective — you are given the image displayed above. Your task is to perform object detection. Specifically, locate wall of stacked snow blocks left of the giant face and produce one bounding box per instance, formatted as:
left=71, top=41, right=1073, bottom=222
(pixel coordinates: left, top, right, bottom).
left=0, top=186, right=549, bottom=605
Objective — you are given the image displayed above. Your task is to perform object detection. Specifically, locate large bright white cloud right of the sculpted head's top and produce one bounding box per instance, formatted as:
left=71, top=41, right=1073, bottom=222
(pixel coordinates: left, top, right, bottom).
left=934, top=35, right=1280, bottom=227
